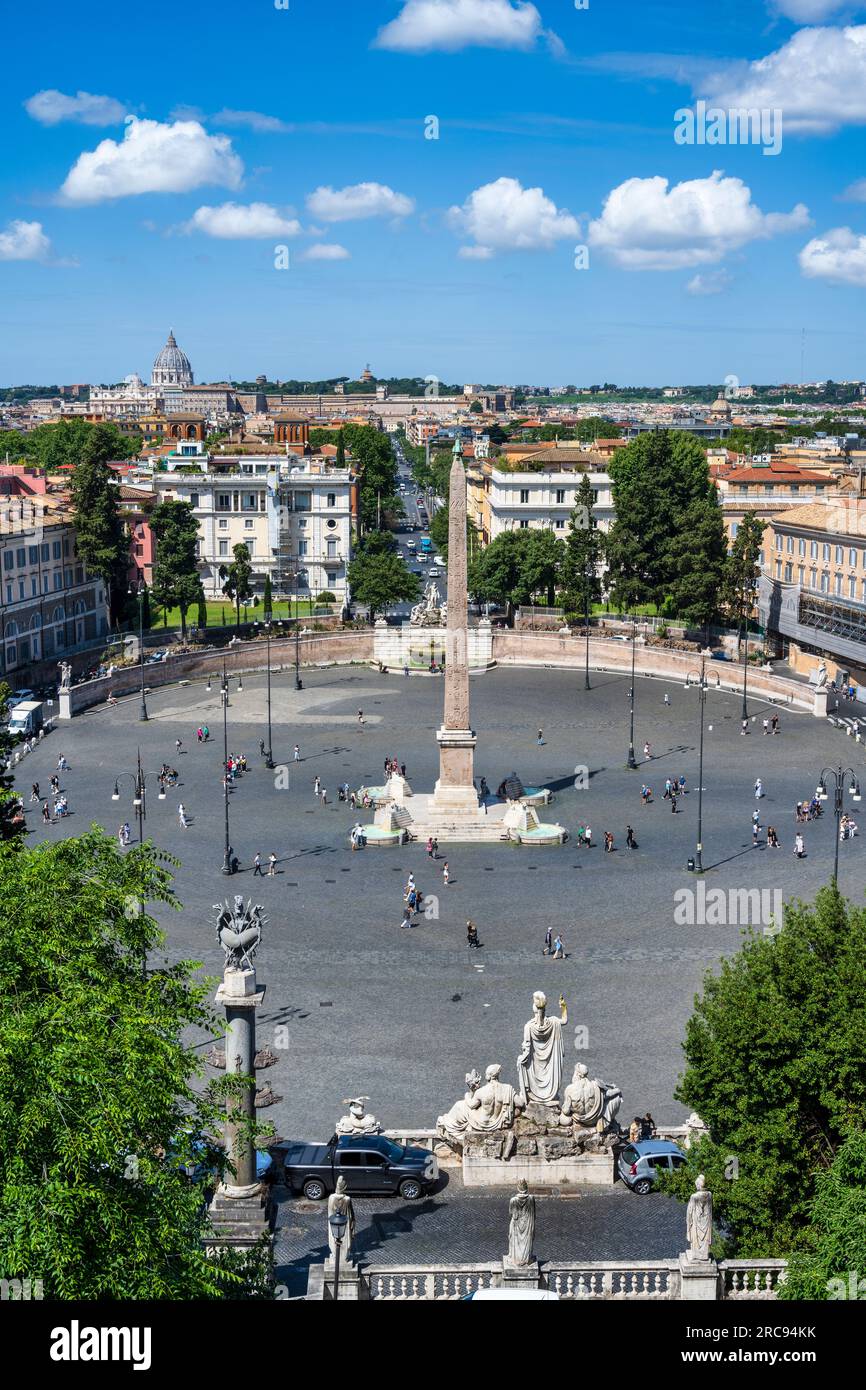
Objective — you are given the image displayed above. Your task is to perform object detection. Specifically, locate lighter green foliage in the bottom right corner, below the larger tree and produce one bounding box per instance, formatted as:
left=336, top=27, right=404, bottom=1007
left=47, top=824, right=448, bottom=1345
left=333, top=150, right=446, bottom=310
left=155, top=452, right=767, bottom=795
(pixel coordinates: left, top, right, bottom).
left=778, top=1130, right=866, bottom=1300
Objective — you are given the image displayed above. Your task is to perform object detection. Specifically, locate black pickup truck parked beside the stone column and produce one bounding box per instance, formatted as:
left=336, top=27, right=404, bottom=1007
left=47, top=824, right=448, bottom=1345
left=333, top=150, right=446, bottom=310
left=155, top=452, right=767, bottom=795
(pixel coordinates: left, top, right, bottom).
left=275, top=1134, right=439, bottom=1202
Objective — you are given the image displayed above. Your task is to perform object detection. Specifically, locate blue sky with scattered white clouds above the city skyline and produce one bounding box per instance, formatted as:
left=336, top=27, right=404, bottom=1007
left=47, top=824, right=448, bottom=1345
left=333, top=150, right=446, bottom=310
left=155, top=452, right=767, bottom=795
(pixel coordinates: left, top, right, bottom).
left=0, top=0, right=866, bottom=385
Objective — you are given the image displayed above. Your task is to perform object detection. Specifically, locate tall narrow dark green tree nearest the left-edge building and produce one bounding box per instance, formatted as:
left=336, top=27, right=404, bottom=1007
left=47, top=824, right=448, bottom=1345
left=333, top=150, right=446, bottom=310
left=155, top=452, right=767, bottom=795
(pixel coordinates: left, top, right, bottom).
left=70, top=425, right=129, bottom=623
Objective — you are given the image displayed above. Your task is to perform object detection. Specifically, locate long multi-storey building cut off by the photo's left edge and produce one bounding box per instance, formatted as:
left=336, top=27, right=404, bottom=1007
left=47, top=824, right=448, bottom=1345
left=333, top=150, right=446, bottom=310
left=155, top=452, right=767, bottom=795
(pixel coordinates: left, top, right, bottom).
left=0, top=486, right=108, bottom=684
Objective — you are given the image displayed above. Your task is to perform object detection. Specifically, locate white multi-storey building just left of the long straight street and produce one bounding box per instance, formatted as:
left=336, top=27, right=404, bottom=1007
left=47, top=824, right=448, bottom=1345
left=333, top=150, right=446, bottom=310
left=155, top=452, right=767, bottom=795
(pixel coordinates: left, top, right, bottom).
left=154, top=446, right=357, bottom=602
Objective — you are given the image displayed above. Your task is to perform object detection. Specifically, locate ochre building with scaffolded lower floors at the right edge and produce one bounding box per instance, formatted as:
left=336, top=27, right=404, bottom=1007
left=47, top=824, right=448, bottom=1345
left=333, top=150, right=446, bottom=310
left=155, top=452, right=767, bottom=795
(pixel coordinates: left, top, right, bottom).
left=758, top=492, right=866, bottom=684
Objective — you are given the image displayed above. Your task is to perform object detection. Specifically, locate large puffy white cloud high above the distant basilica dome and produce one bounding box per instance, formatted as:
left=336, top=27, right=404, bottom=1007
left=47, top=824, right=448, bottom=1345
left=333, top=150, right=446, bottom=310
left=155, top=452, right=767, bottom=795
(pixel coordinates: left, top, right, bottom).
left=61, top=117, right=243, bottom=203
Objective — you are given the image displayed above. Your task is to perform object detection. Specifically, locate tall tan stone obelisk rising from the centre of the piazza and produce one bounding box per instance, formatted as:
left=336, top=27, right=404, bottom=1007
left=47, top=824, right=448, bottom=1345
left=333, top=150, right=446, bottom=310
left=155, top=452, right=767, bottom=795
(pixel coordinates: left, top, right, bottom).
left=432, top=438, right=478, bottom=812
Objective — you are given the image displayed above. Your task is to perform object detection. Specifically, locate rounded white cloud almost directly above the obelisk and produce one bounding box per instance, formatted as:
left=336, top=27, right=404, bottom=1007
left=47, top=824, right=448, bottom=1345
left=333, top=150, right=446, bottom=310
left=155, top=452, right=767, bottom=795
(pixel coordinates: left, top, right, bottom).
left=448, top=178, right=580, bottom=260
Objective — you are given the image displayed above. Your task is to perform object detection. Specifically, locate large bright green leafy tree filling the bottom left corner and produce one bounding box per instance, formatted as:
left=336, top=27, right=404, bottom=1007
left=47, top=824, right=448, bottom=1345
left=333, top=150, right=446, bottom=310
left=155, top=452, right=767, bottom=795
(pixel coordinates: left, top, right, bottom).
left=0, top=827, right=268, bottom=1300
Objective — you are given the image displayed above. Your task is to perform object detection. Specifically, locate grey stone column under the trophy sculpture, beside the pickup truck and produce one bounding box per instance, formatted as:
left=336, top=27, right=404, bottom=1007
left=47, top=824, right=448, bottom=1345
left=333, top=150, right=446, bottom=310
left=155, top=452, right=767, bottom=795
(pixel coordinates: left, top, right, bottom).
left=210, top=967, right=270, bottom=1245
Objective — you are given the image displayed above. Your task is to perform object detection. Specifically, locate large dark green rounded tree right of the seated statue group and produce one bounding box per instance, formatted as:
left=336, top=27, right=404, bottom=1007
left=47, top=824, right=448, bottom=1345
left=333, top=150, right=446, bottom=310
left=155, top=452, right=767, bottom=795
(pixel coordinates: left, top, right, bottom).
left=661, top=887, right=866, bottom=1258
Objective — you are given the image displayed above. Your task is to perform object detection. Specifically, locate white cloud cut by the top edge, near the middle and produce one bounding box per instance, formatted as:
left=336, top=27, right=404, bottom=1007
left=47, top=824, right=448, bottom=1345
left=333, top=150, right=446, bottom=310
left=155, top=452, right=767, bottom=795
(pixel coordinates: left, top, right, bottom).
left=373, top=0, right=545, bottom=53
